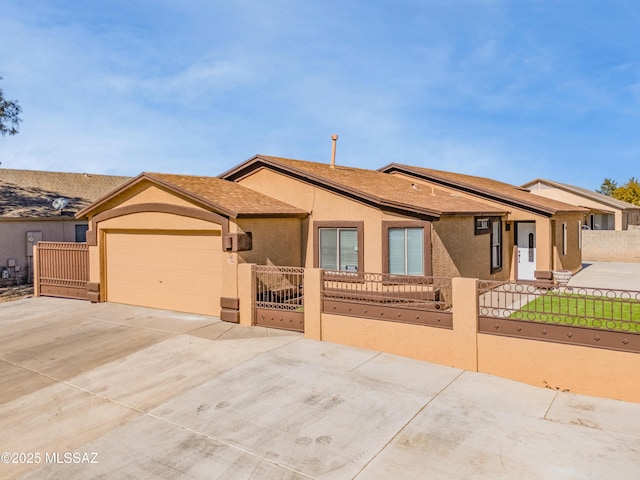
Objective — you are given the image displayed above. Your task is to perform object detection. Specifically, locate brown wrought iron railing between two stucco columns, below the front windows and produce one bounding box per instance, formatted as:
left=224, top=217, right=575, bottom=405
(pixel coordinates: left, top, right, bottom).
left=322, top=270, right=451, bottom=311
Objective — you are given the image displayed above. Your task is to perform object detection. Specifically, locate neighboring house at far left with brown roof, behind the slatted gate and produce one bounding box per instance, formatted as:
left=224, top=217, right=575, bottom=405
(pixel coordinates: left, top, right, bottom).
left=0, top=168, right=128, bottom=285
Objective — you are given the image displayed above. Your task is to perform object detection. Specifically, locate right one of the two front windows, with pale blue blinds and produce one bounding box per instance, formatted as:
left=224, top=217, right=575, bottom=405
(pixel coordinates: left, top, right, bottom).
left=388, top=227, right=424, bottom=275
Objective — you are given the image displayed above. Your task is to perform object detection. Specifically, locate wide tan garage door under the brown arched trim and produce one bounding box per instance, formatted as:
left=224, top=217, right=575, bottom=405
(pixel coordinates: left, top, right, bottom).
left=106, top=232, right=222, bottom=316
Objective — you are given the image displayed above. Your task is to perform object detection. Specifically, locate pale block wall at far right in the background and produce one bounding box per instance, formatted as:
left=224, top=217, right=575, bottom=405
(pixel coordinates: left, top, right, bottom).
left=582, top=230, right=640, bottom=262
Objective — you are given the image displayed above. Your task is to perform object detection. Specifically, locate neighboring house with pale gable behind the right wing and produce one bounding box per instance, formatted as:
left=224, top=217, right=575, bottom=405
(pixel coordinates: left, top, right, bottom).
left=522, top=178, right=640, bottom=230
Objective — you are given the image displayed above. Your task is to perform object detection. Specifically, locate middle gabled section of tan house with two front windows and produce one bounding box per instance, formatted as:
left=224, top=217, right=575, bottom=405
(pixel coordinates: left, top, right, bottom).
left=220, top=155, right=508, bottom=279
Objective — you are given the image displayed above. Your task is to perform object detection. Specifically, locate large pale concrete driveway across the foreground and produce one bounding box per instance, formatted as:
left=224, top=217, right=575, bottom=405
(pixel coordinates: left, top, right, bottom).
left=0, top=298, right=640, bottom=480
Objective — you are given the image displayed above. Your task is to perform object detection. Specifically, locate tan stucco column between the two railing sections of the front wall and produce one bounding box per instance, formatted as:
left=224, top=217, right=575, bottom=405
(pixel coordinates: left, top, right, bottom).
left=451, top=277, right=478, bottom=372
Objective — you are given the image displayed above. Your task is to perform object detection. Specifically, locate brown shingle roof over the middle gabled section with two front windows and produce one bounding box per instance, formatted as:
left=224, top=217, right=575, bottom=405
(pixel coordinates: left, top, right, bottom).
left=221, top=155, right=505, bottom=217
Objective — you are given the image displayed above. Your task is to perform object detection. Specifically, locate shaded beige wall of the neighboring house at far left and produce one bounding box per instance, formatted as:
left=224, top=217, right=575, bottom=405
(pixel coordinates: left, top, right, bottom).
left=0, top=217, right=87, bottom=284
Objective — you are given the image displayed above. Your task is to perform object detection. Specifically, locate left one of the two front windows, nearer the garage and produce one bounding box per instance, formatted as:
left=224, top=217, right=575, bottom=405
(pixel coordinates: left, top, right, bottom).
left=318, top=227, right=359, bottom=272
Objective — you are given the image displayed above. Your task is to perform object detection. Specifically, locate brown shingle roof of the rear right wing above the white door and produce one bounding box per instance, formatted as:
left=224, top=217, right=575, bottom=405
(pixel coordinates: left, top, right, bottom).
left=380, top=163, right=584, bottom=215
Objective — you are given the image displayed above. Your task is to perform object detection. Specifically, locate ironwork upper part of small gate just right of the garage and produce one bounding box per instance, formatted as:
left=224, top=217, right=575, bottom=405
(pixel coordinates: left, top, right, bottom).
left=253, top=265, right=304, bottom=311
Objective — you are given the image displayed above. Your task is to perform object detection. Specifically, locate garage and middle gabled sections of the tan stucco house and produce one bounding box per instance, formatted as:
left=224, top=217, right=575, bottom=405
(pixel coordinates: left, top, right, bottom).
left=77, top=155, right=508, bottom=319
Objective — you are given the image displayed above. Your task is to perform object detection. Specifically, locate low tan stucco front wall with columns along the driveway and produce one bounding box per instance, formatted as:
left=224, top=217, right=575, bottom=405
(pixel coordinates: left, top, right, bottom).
left=296, top=272, right=640, bottom=402
